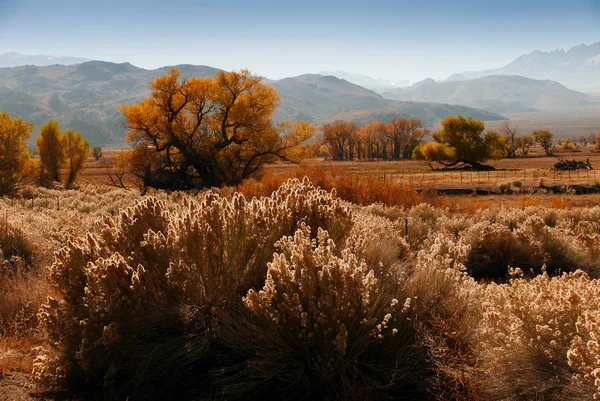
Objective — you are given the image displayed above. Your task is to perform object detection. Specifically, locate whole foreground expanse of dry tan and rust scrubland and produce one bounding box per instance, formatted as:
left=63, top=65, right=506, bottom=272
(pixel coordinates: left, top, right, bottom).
left=0, top=177, right=600, bottom=400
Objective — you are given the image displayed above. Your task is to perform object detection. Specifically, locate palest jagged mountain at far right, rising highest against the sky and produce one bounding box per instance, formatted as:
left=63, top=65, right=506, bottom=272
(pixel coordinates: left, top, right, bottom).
left=447, top=42, right=600, bottom=93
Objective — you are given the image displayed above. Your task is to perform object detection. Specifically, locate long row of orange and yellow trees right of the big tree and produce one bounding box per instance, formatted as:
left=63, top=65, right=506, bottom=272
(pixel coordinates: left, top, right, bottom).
left=319, top=116, right=600, bottom=169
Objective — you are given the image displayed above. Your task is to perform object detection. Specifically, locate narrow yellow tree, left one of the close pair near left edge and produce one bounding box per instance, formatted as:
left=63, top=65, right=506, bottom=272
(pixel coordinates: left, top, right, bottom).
left=36, top=121, right=64, bottom=183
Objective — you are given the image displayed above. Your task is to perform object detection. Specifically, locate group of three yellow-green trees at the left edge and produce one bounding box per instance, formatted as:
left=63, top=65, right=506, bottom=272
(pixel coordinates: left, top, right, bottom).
left=0, top=111, right=90, bottom=195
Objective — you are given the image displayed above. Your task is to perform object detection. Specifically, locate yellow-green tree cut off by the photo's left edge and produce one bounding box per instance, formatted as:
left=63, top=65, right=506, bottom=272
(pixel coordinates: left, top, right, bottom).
left=0, top=111, right=34, bottom=195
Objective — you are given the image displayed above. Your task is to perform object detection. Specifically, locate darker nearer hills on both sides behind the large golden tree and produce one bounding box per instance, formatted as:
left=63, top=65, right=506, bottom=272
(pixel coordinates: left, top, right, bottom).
left=0, top=61, right=503, bottom=145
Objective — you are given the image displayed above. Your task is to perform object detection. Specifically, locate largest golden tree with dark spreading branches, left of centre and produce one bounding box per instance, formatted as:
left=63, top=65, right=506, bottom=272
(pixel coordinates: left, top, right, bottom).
left=120, top=68, right=315, bottom=189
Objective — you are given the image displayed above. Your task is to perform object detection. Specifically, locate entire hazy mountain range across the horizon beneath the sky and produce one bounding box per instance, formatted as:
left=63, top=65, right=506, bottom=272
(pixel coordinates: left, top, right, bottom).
left=0, top=43, right=600, bottom=145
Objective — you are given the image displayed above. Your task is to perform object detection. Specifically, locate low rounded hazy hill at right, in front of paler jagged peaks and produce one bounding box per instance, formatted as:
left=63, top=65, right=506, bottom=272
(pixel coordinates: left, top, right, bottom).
left=381, top=75, right=597, bottom=113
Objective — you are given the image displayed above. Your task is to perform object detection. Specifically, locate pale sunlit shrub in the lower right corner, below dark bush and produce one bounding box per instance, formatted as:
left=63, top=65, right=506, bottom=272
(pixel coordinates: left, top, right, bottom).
left=478, top=271, right=600, bottom=401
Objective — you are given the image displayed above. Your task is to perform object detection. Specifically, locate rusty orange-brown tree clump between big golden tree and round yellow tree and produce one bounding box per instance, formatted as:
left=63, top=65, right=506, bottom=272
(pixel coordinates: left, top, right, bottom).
left=322, top=118, right=429, bottom=160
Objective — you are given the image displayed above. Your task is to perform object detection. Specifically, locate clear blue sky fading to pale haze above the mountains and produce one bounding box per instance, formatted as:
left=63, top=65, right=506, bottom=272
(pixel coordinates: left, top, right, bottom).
left=0, top=0, right=600, bottom=82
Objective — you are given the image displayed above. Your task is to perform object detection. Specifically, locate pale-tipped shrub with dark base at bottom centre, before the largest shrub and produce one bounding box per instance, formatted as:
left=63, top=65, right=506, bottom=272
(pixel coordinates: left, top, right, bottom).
left=218, top=226, right=432, bottom=400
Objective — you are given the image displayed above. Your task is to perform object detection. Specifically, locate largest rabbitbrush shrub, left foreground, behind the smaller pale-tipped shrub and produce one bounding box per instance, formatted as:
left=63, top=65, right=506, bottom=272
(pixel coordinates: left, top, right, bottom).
left=35, top=180, right=352, bottom=399
